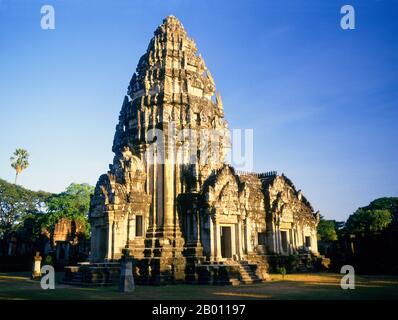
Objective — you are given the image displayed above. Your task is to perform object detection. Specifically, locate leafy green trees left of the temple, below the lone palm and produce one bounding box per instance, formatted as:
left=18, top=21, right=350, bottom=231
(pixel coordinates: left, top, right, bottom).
left=0, top=179, right=94, bottom=241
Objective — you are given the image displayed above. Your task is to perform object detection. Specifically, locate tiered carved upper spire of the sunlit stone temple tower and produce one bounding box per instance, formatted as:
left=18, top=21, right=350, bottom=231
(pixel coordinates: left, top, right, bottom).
left=113, top=16, right=229, bottom=185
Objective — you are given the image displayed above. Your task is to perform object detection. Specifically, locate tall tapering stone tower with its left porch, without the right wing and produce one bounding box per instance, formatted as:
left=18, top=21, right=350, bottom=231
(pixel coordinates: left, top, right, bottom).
left=90, top=16, right=228, bottom=281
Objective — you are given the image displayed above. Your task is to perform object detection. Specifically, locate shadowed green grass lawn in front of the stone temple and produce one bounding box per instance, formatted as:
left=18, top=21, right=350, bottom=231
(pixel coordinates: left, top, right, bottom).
left=0, top=273, right=398, bottom=300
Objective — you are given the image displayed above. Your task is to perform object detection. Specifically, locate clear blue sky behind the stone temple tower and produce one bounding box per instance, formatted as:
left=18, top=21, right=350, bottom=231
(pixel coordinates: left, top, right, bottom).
left=0, top=0, right=398, bottom=220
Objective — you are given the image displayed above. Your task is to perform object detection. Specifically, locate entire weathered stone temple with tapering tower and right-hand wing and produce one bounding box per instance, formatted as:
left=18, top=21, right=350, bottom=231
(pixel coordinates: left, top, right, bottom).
left=79, top=16, right=319, bottom=284
